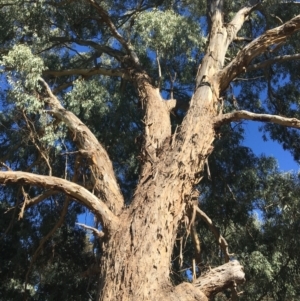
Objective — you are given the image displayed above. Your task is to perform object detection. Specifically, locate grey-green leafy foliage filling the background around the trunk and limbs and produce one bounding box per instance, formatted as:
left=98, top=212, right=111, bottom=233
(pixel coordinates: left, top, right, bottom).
left=0, top=0, right=300, bottom=301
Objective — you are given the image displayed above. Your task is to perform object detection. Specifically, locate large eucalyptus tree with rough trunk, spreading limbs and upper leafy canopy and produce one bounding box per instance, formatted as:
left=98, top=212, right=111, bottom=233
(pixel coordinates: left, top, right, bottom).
left=0, top=0, right=300, bottom=300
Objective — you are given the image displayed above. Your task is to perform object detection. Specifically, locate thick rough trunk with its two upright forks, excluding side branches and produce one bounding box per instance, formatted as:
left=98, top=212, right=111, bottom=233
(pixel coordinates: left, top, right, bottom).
left=95, top=2, right=248, bottom=301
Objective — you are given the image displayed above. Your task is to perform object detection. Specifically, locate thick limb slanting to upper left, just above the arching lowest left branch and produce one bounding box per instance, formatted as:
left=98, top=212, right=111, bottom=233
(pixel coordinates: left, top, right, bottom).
left=40, top=78, right=124, bottom=214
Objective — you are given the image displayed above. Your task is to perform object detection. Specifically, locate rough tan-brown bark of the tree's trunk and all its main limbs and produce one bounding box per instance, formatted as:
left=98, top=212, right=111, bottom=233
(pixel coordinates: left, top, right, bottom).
left=0, top=0, right=300, bottom=301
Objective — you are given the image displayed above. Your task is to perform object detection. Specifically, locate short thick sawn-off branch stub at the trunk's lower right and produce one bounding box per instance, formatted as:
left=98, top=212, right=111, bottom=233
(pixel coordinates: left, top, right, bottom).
left=193, top=260, right=245, bottom=298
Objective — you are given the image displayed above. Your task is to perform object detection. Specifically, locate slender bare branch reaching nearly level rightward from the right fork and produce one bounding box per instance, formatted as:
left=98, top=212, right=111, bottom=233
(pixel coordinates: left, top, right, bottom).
left=215, top=110, right=300, bottom=129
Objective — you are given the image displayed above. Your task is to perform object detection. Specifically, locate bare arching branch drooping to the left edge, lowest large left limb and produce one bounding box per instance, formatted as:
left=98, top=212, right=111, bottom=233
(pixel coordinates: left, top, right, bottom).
left=0, top=171, right=118, bottom=229
